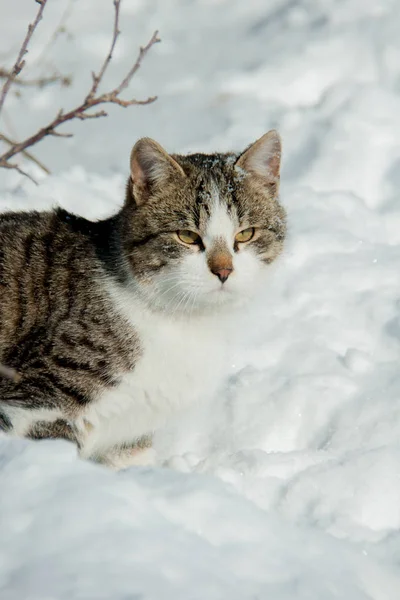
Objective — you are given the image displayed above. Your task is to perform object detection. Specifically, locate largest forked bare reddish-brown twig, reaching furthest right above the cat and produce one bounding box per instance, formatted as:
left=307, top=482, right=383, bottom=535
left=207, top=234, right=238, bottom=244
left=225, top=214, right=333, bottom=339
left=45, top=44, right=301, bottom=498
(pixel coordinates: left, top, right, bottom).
left=0, top=0, right=160, bottom=173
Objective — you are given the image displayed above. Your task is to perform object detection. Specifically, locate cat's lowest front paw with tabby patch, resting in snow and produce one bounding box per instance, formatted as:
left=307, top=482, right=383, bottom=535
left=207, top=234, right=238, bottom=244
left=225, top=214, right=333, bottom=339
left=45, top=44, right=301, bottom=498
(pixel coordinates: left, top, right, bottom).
left=91, top=435, right=156, bottom=471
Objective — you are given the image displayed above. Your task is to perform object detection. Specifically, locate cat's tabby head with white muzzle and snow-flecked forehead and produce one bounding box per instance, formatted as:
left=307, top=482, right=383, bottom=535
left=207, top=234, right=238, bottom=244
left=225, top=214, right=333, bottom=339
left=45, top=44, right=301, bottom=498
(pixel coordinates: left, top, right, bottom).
left=122, top=131, right=286, bottom=314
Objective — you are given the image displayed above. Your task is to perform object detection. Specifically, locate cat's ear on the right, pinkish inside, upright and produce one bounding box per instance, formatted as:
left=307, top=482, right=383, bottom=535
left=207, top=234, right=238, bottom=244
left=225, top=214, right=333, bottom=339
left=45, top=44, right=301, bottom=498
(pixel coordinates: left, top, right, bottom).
left=235, top=129, right=282, bottom=185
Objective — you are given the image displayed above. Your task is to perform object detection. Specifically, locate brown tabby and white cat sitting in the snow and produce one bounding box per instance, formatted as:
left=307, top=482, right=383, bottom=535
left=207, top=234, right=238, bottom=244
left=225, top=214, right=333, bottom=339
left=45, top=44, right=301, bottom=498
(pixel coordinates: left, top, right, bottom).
left=0, top=131, right=286, bottom=468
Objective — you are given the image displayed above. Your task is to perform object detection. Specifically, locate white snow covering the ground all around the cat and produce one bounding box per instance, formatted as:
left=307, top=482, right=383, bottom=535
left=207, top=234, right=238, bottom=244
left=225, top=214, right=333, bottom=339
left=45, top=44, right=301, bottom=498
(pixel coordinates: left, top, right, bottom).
left=0, top=0, right=400, bottom=600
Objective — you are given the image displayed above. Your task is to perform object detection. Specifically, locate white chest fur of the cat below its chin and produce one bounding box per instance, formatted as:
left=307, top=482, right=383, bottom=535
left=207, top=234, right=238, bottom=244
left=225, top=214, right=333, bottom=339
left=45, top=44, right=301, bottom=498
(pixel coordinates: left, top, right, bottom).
left=79, top=292, right=228, bottom=455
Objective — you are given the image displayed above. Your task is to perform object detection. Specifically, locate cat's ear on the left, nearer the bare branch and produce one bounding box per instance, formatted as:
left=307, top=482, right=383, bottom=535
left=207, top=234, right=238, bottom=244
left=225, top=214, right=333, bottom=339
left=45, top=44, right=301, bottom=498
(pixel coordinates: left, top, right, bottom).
left=130, top=138, right=186, bottom=204
